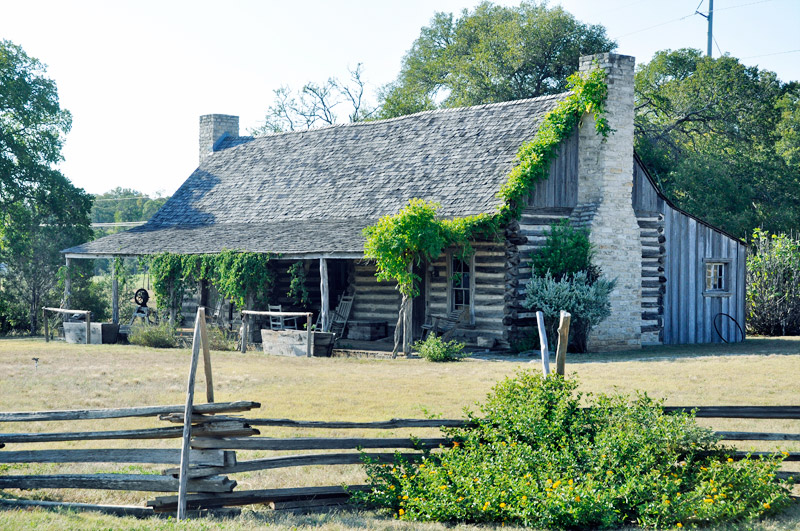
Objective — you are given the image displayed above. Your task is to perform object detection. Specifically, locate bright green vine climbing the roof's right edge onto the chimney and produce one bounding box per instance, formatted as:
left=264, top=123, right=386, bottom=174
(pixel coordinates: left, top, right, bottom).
left=364, top=69, right=611, bottom=297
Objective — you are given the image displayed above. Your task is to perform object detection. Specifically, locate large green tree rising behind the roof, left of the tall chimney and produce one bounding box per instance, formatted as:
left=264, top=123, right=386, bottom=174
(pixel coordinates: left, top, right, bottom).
left=379, top=2, right=616, bottom=118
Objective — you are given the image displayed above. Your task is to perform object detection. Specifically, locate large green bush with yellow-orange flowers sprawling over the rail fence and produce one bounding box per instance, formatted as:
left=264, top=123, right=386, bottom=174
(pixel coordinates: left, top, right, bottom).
left=356, top=372, right=790, bottom=529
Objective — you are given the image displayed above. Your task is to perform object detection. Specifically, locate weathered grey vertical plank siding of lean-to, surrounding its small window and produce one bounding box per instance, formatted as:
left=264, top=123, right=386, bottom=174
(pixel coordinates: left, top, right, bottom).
left=664, top=205, right=746, bottom=344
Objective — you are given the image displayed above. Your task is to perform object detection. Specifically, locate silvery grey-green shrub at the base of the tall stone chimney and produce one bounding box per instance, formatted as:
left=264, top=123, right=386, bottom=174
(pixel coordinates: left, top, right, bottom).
left=523, top=271, right=616, bottom=352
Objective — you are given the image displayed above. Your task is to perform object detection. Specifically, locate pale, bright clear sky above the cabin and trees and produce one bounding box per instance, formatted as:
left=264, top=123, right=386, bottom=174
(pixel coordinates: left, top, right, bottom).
left=0, top=0, right=800, bottom=195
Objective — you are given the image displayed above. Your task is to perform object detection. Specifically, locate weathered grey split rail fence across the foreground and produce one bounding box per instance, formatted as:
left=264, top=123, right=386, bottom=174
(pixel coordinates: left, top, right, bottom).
left=0, top=308, right=800, bottom=519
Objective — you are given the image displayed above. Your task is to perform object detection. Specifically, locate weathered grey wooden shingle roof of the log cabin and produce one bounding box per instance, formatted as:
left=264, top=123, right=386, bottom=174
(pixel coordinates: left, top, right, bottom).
left=64, top=94, right=566, bottom=256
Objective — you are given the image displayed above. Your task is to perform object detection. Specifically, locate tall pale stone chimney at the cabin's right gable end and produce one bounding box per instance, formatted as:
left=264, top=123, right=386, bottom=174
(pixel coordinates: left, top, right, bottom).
left=572, top=53, right=642, bottom=350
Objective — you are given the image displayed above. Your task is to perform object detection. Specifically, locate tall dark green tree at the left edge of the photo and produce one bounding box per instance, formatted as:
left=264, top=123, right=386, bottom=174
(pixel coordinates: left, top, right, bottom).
left=0, top=40, right=92, bottom=332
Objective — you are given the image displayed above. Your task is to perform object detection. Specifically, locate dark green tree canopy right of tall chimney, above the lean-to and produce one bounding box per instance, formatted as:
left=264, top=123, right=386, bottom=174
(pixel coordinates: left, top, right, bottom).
left=635, top=49, right=800, bottom=237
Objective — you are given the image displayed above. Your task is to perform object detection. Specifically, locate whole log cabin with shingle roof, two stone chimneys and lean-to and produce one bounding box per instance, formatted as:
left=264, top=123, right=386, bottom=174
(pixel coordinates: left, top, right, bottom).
left=64, top=53, right=746, bottom=351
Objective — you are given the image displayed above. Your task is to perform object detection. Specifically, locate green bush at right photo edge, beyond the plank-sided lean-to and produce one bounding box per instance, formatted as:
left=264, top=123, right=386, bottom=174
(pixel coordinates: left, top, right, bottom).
left=745, top=230, right=800, bottom=336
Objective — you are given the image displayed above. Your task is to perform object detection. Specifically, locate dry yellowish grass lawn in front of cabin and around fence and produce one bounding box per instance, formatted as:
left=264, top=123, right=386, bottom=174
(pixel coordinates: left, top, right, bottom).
left=0, top=338, right=800, bottom=531
